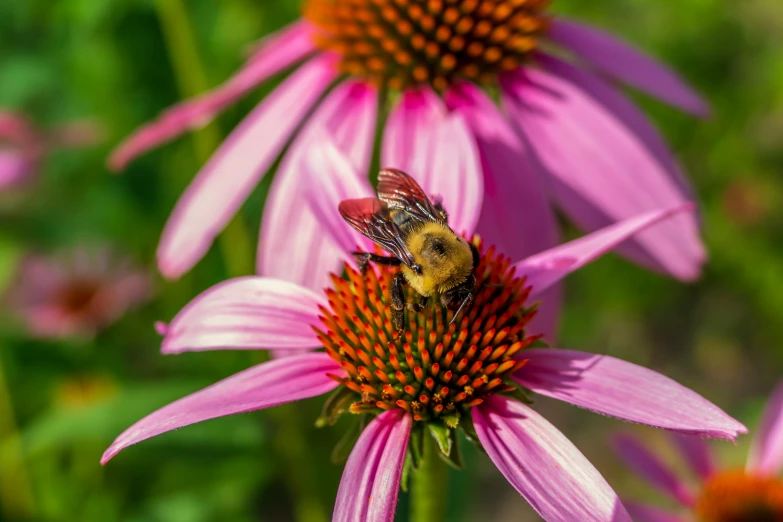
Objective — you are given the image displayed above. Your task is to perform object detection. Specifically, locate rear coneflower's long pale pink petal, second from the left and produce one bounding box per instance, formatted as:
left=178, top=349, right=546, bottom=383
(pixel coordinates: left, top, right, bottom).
left=158, top=56, right=336, bottom=278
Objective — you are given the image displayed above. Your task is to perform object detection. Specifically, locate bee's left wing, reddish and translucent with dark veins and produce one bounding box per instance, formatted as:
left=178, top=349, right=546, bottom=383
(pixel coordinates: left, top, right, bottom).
left=338, top=198, right=415, bottom=266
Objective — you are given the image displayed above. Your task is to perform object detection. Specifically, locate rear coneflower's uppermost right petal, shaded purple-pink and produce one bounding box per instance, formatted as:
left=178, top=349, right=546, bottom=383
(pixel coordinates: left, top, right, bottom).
left=549, top=18, right=709, bottom=116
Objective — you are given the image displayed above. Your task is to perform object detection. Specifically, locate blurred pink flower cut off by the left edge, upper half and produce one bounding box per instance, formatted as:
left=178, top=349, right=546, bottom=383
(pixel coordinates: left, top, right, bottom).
left=0, top=110, right=100, bottom=191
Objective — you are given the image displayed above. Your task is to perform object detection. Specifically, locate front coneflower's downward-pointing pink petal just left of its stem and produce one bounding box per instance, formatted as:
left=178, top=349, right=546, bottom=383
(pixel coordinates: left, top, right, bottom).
left=332, top=410, right=412, bottom=522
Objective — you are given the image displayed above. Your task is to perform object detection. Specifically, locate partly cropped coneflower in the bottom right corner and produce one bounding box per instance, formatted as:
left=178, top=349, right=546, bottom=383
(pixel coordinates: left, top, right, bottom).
left=615, top=383, right=783, bottom=522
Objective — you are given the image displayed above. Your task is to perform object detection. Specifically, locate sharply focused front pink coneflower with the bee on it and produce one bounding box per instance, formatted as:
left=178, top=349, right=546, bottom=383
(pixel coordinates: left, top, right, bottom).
left=102, top=179, right=746, bottom=522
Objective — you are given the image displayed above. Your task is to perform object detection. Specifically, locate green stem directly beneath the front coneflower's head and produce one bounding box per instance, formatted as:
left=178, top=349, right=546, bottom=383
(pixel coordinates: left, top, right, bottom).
left=410, top=430, right=448, bottom=522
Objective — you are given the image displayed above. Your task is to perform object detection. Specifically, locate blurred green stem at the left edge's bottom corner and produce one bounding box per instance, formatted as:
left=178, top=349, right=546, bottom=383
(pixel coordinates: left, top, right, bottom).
left=0, top=352, right=35, bottom=520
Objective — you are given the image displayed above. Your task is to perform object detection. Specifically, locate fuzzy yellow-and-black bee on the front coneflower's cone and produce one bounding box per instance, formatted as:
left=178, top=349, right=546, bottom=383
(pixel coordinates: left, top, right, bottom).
left=338, top=169, right=479, bottom=331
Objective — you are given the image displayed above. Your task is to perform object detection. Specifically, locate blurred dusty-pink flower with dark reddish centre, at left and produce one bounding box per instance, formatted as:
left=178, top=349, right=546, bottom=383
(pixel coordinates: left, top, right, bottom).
left=9, top=249, right=151, bottom=338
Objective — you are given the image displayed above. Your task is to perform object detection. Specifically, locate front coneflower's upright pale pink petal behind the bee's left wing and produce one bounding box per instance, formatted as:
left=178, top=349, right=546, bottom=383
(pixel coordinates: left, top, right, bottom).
left=300, top=136, right=375, bottom=252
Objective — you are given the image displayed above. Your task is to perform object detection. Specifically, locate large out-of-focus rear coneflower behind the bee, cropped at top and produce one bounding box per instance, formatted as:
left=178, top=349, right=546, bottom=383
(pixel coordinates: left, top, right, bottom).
left=109, top=0, right=707, bottom=296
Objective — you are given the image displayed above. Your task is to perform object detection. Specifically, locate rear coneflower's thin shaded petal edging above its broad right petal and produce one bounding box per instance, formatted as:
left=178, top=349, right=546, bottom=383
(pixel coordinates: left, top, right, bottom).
left=536, top=53, right=693, bottom=198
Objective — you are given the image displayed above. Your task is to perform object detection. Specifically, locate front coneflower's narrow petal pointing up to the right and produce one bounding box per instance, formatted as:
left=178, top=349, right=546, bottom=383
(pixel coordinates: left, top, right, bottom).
left=516, top=203, right=693, bottom=296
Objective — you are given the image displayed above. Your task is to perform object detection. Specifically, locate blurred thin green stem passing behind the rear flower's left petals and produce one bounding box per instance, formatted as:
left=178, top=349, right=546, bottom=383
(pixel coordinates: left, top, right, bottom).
left=155, top=0, right=254, bottom=277
